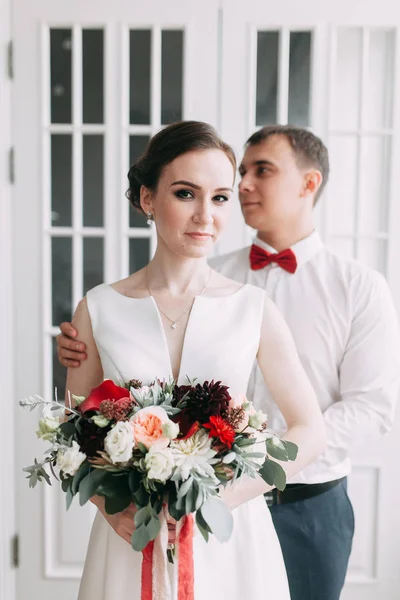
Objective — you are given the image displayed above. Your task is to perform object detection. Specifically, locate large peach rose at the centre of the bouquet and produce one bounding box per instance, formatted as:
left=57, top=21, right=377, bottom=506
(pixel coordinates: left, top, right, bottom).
left=131, top=406, right=171, bottom=449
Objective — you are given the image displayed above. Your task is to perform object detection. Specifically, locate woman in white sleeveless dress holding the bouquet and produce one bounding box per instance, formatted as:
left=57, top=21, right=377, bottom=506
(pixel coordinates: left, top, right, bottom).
left=67, top=121, right=325, bottom=600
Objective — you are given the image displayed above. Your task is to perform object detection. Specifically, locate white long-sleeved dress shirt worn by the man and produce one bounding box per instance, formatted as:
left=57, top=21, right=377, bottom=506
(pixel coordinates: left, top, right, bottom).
left=210, top=232, right=400, bottom=483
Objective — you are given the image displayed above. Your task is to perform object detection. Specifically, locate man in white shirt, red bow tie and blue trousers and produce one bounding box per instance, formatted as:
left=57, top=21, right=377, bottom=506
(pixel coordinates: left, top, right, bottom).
left=58, top=126, right=400, bottom=600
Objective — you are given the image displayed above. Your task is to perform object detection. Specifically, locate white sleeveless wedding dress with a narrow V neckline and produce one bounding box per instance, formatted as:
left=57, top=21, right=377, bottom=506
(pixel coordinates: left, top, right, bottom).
left=78, top=284, right=290, bottom=600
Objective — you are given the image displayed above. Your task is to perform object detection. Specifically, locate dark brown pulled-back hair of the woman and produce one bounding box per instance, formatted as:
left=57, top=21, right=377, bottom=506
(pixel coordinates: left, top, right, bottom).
left=126, top=121, right=236, bottom=212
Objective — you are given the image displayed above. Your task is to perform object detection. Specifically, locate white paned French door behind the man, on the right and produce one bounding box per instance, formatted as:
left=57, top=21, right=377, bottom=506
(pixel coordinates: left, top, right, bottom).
left=220, top=0, right=400, bottom=600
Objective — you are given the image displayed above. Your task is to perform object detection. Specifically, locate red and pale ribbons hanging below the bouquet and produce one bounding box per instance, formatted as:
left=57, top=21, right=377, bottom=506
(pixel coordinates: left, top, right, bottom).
left=141, top=509, right=194, bottom=600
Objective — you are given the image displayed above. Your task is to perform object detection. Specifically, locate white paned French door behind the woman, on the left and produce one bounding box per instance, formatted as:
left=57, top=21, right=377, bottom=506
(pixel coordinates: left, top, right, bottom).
left=13, top=0, right=218, bottom=600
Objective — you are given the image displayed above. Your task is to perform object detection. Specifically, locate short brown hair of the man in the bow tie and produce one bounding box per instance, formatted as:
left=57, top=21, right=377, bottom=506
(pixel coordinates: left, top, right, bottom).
left=246, top=125, right=329, bottom=204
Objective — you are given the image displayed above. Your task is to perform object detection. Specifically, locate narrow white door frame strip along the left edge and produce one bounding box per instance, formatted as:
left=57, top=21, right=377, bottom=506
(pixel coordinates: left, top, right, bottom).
left=0, top=0, right=16, bottom=600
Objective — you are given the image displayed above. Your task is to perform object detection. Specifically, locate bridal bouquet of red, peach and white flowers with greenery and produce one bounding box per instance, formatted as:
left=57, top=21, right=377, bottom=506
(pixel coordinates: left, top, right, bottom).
left=20, top=380, right=297, bottom=596
